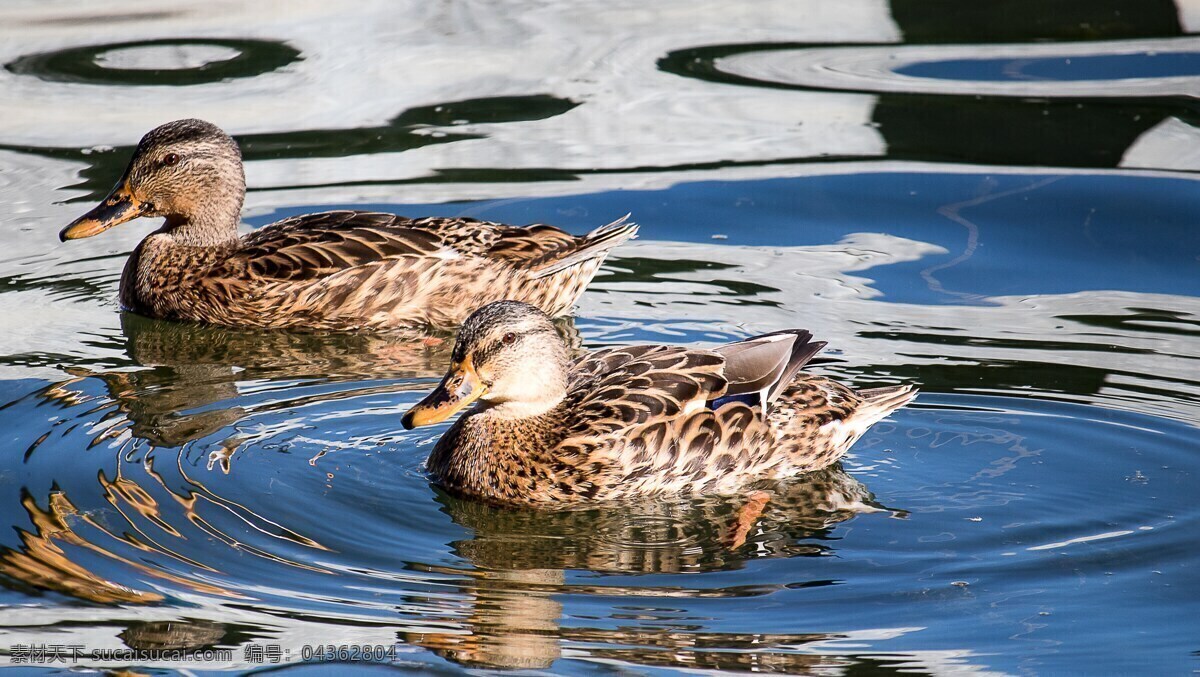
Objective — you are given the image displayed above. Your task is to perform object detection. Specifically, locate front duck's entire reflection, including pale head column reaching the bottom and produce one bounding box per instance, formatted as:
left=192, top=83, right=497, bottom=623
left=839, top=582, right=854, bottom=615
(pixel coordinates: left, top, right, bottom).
left=402, top=466, right=887, bottom=672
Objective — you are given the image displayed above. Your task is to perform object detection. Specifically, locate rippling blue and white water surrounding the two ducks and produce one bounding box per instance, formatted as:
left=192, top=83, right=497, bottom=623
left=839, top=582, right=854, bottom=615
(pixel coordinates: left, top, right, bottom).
left=0, top=0, right=1200, bottom=675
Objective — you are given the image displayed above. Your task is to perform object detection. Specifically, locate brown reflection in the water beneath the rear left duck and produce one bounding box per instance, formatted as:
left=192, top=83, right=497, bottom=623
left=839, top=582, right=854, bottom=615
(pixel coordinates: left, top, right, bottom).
left=32, top=313, right=463, bottom=447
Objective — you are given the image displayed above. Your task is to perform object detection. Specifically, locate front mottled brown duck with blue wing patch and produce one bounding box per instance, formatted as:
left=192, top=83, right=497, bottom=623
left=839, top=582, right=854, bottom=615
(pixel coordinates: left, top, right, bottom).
left=401, top=301, right=917, bottom=509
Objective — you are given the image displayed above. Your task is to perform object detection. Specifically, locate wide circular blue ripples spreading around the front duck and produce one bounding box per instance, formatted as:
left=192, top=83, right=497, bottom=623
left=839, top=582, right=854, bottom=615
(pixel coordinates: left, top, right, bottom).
left=0, top=345, right=1200, bottom=670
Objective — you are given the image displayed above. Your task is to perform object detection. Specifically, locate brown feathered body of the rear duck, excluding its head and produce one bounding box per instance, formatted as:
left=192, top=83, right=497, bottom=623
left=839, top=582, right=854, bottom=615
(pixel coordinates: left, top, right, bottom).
left=121, top=211, right=632, bottom=330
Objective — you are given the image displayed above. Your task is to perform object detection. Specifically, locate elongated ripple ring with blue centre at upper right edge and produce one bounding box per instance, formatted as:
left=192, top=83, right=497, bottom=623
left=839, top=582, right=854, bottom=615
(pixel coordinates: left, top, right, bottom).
left=681, top=38, right=1200, bottom=98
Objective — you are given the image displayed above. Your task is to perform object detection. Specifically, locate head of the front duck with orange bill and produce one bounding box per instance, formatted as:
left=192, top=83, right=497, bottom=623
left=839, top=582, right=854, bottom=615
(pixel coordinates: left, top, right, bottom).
left=401, top=301, right=570, bottom=430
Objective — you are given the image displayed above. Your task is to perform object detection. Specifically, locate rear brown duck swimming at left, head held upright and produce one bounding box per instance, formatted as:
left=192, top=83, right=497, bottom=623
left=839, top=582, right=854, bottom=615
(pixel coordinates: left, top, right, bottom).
left=60, top=119, right=637, bottom=331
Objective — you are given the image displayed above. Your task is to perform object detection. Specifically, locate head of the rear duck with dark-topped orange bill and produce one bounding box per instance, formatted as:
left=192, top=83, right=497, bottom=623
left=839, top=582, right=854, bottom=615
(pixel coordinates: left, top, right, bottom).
left=59, top=120, right=246, bottom=245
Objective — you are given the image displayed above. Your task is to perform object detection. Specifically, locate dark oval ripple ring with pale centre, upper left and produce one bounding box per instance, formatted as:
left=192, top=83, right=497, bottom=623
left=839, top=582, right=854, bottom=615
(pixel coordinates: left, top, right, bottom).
left=5, top=38, right=301, bottom=86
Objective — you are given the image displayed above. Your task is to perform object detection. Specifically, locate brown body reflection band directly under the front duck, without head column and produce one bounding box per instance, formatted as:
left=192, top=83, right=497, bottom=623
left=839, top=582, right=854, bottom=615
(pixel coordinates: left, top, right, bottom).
left=439, top=466, right=883, bottom=574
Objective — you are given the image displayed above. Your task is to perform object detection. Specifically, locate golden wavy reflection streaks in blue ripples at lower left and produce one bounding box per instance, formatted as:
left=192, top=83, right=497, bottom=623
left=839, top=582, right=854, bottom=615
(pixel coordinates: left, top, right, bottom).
left=0, top=459, right=338, bottom=605
